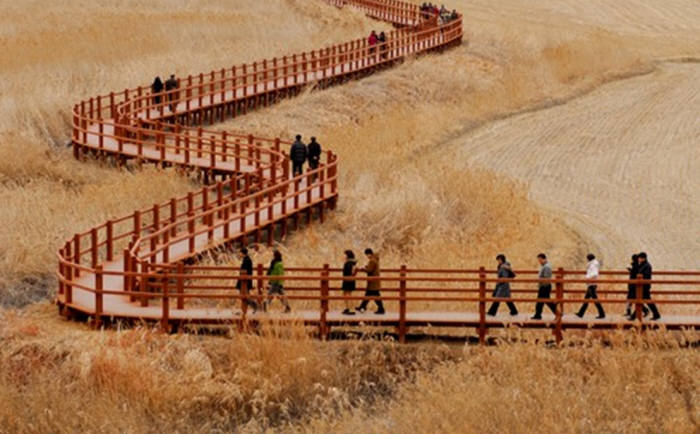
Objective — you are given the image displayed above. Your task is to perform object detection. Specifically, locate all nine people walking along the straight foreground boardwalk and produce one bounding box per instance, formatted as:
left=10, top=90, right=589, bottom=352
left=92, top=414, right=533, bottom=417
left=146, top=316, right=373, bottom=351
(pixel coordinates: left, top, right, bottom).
left=236, top=248, right=661, bottom=321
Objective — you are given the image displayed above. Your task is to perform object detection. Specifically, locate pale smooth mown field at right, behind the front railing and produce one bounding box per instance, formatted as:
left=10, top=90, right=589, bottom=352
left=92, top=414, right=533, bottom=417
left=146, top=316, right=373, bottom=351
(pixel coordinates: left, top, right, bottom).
left=448, top=63, right=700, bottom=269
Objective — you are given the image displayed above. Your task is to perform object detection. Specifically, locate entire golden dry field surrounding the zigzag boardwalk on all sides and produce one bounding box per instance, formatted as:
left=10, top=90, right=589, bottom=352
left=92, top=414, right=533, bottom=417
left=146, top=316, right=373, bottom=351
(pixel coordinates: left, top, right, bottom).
left=0, top=0, right=700, bottom=433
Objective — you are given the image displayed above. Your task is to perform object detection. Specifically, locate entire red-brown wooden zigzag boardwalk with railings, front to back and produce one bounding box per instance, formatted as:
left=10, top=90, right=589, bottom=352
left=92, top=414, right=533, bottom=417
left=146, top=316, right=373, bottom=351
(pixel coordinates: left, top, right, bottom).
left=52, top=0, right=700, bottom=341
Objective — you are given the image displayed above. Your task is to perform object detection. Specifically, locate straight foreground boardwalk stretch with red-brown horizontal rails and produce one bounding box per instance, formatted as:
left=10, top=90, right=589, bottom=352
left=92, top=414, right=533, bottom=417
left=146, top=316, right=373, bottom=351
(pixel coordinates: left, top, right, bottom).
left=56, top=263, right=700, bottom=343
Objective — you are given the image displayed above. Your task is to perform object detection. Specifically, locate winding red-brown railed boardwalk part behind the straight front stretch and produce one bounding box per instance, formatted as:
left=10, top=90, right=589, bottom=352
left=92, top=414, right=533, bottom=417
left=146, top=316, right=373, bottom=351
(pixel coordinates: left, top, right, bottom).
left=53, top=0, right=462, bottom=324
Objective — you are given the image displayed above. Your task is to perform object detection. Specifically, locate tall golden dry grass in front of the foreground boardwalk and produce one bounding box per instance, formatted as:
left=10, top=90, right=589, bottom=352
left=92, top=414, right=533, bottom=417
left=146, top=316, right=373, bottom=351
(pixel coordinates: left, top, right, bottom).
left=0, top=305, right=700, bottom=433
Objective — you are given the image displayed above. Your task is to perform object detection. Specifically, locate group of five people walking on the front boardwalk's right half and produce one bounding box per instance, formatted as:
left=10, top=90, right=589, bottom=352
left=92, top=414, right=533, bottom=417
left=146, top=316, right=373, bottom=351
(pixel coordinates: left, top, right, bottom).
left=488, top=252, right=661, bottom=321
